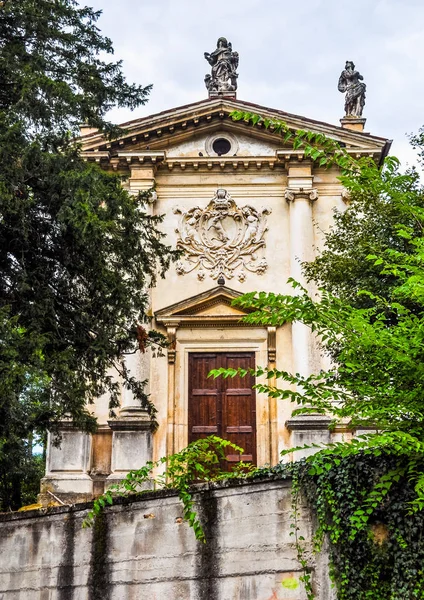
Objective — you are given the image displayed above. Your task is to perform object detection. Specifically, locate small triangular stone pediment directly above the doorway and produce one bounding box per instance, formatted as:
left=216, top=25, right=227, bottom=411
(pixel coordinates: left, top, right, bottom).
left=155, top=286, right=250, bottom=326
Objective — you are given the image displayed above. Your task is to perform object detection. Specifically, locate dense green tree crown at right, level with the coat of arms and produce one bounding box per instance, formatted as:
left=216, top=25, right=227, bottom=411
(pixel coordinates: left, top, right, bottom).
left=303, top=157, right=424, bottom=308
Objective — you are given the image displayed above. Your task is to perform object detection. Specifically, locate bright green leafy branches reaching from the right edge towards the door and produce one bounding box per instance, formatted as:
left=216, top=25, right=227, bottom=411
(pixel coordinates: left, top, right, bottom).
left=214, top=276, right=424, bottom=432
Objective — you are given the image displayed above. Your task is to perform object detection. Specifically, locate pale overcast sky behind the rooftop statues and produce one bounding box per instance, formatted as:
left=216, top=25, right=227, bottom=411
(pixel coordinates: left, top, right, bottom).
left=88, top=0, right=424, bottom=163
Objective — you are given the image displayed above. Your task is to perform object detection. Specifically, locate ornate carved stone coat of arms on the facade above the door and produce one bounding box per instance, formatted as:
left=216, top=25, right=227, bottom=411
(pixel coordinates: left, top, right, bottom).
left=174, top=189, right=271, bottom=281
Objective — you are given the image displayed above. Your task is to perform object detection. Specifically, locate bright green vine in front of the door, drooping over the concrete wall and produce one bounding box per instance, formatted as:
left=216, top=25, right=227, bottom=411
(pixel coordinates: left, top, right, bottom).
left=83, top=435, right=254, bottom=542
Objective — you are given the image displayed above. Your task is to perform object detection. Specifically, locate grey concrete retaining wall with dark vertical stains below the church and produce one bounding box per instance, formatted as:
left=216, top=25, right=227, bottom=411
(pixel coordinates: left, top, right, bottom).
left=0, top=479, right=333, bottom=600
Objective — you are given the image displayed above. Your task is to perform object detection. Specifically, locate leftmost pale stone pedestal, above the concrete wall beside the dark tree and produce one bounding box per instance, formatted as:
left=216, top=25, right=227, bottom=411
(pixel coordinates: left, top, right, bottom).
left=39, top=425, right=93, bottom=506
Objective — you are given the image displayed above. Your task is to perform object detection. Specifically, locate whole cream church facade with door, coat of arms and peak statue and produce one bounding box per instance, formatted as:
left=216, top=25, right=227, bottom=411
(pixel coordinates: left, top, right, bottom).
left=42, top=43, right=390, bottom=500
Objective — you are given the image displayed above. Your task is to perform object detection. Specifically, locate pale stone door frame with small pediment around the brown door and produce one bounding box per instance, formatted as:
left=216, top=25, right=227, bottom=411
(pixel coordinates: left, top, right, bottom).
left=155, top=286, right=279, bottom=466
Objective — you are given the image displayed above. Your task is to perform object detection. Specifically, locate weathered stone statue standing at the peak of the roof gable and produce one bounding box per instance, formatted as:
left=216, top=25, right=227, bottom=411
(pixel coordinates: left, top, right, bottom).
left=205, top=38, right=239, bottom=96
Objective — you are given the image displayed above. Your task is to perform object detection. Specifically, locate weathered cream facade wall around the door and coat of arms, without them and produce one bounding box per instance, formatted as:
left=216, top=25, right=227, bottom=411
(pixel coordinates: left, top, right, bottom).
left=40, top=106, right=364, bottom=502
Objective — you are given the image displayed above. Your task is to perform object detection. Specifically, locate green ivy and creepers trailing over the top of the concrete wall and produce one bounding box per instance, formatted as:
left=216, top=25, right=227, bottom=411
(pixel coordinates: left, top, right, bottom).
left=83, top=435, right=424, bottom=600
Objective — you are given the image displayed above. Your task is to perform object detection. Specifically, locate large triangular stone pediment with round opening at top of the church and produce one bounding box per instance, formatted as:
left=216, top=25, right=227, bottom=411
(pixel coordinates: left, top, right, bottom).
left=80, top=98, right=387, bottom=160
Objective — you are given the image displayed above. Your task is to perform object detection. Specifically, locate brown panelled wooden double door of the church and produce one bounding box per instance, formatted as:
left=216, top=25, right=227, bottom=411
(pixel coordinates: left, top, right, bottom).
left=188, top=352, right=256, bottom=464
